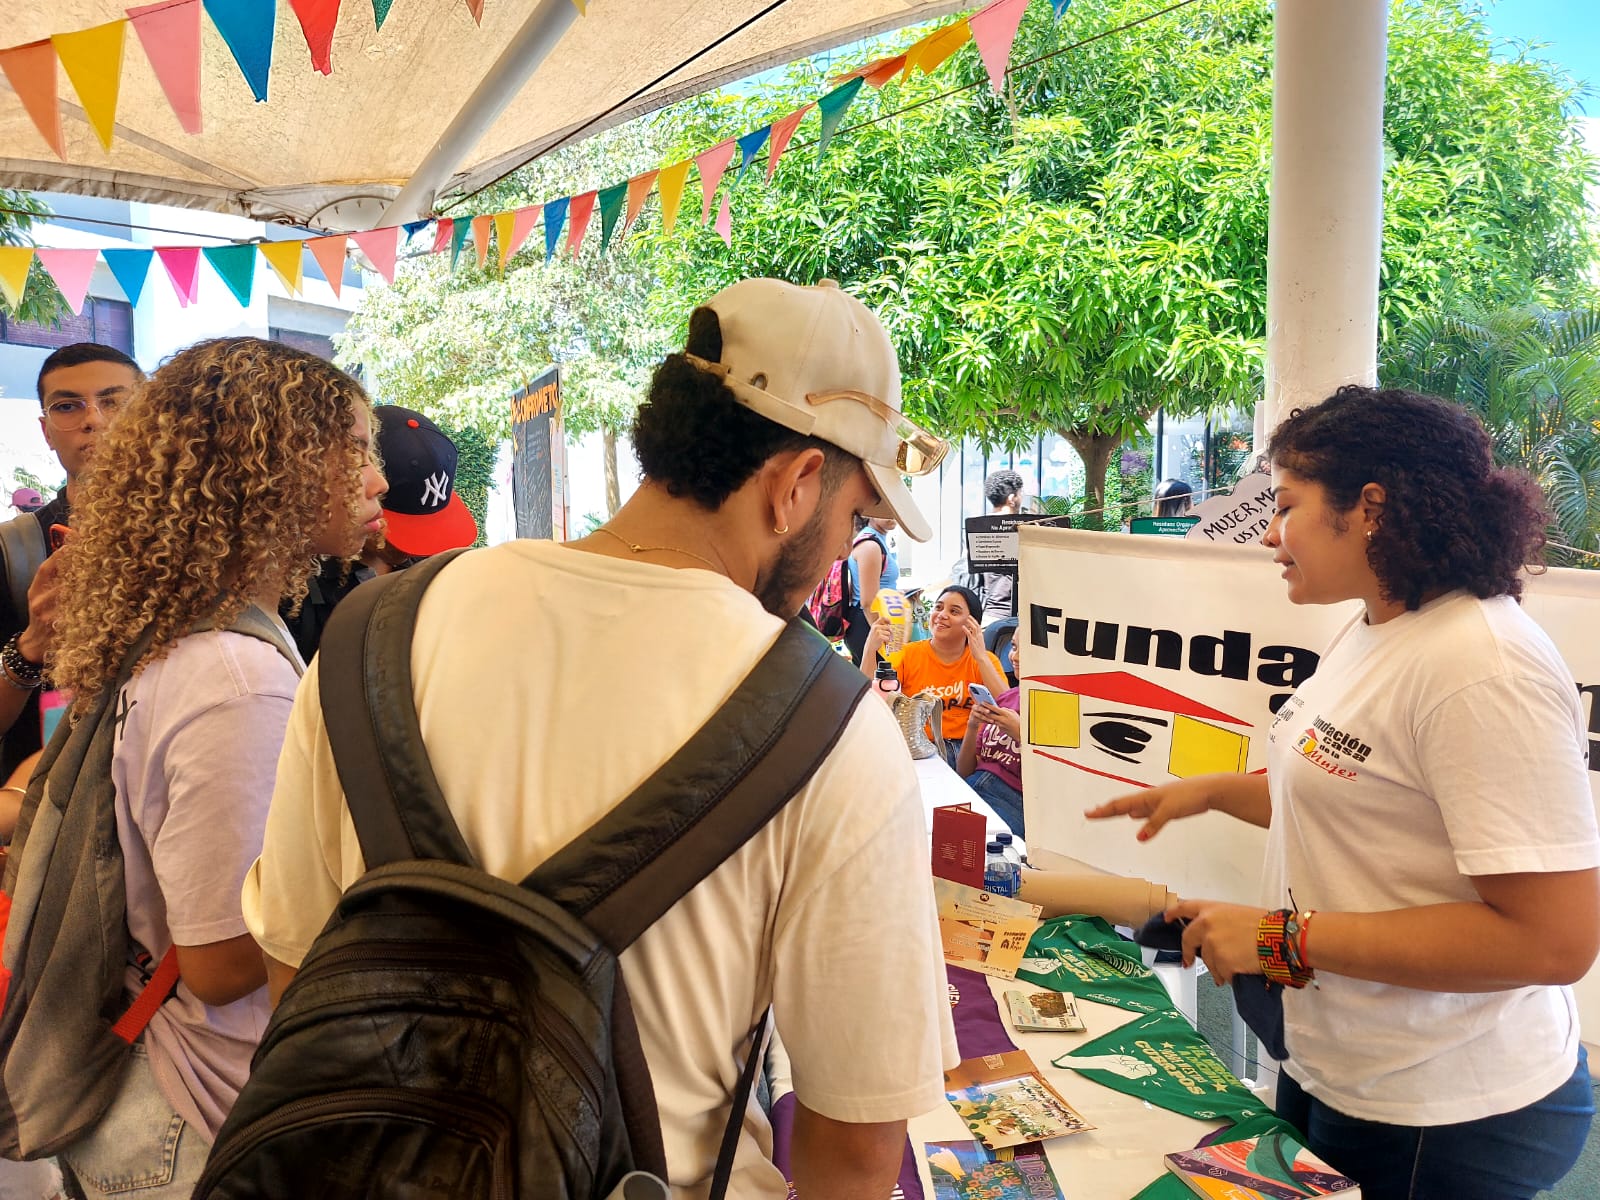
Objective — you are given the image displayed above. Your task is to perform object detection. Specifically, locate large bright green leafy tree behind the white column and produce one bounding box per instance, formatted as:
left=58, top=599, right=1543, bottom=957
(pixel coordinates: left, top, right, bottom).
left=651, top=0, right=1594, bottom=524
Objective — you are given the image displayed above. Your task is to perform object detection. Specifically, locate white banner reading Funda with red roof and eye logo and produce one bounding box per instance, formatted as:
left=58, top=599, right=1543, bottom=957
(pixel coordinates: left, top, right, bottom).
left=1018, top=526, right=1600, bottom=1042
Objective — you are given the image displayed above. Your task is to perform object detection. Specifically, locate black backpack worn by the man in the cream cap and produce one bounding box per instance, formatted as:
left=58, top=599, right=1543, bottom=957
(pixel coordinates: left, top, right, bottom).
left=194, top=554, right=866, bottom=1200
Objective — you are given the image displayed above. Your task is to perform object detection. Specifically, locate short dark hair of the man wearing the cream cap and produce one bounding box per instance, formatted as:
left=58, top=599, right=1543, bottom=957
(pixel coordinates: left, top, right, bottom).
left=632, top=309, right=859, bottom=512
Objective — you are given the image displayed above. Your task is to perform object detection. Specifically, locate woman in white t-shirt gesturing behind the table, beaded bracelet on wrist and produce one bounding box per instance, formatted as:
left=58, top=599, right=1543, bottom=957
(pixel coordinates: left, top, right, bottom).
left=1088, top=387, right=1600, bottom=1200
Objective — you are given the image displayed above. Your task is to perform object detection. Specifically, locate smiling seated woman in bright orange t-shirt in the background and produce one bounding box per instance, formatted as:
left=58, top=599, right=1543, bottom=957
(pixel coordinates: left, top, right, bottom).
left=861, top=586, right=1010, bottom=765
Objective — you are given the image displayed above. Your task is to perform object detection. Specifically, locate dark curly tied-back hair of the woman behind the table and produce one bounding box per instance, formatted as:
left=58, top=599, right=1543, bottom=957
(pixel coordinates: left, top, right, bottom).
left=1267, top=386, right=1549, bottom=610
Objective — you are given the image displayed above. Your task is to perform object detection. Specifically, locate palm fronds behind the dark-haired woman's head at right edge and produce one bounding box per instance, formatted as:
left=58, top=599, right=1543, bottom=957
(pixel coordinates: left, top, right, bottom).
left=1382, top=301, right=1600, bottom=568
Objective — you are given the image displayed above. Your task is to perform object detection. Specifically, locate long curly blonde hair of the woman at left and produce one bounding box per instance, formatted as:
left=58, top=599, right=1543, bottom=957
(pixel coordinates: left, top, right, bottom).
left=50, top=338, right=377, bottom=696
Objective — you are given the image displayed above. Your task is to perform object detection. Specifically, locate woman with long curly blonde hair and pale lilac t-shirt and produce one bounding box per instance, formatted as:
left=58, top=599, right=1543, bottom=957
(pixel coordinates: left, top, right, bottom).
left=39, top=338, right=386, bottom=1200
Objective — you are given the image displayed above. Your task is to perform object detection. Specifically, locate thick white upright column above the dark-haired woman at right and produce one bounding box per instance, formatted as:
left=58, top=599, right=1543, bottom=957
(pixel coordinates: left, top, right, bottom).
left=1256, top=0, right=1389, bottom=448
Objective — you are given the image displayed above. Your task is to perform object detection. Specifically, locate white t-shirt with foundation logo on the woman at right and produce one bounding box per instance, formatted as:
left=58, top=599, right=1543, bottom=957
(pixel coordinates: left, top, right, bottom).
left=1262, top=592, right=1600, bottom=1125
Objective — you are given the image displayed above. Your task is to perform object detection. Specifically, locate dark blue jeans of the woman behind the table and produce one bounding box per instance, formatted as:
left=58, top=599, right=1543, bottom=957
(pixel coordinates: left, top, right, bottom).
left=1278, top=1046, right=1595, bottom=1200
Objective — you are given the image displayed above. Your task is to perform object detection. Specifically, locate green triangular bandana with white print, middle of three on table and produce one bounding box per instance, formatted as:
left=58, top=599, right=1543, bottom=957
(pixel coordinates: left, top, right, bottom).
left=1051, top=1010, right=1272, bottom=1122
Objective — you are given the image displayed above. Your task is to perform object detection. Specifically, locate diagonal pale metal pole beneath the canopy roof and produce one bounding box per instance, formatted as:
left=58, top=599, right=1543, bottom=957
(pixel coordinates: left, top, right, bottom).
left=379, top=0, right=578, bottom=226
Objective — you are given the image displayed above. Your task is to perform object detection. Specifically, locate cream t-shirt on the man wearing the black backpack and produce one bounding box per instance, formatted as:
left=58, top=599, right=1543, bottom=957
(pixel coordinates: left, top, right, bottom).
left=243, top=541, right=957, bottom=1200
